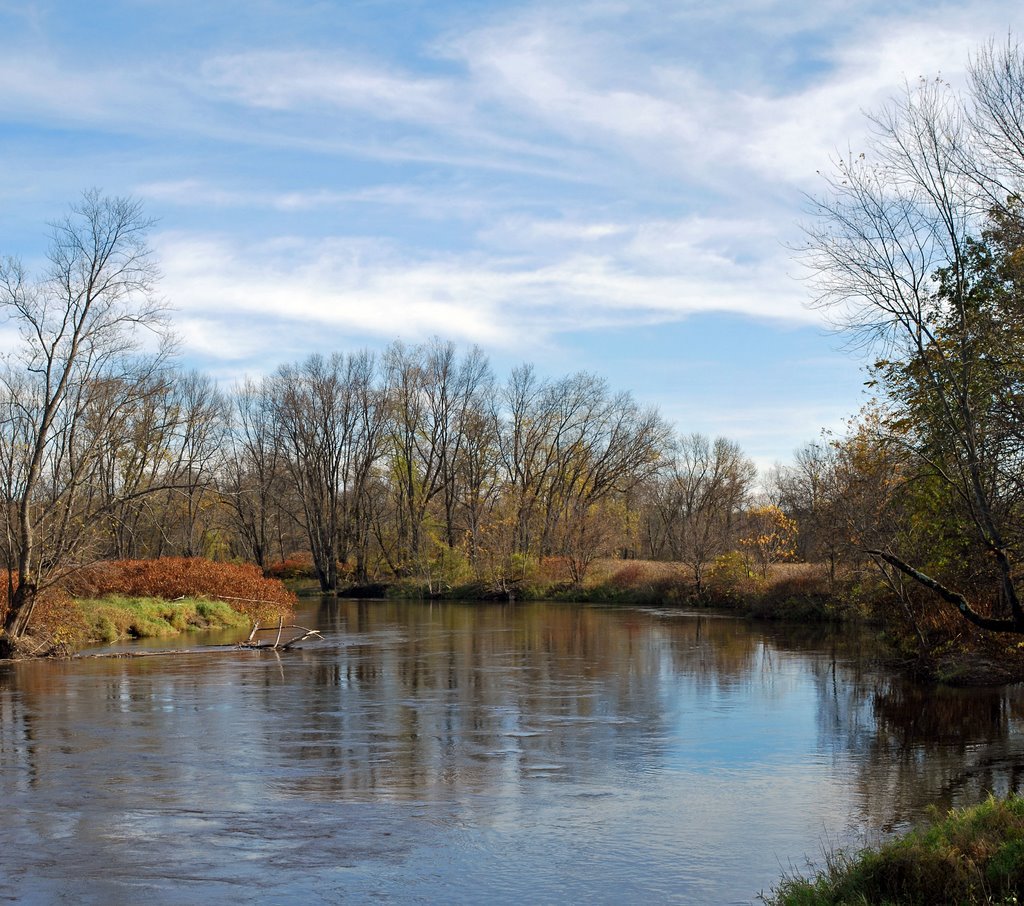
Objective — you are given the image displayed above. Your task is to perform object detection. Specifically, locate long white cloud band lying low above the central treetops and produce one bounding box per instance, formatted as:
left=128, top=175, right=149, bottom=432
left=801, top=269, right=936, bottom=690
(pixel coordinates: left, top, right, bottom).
left=158, top=213, right=814, bottom=362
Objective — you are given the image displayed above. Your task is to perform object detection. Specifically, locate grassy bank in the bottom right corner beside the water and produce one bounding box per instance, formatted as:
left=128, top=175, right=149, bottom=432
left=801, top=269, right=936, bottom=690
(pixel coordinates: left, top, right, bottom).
left=765, top=794, right=1024, bottom=906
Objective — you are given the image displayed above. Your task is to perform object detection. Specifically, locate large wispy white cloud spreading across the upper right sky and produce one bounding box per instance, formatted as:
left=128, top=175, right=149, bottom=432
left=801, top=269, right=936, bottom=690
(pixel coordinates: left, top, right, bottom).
left=434, top=3, right=1024, bottom=190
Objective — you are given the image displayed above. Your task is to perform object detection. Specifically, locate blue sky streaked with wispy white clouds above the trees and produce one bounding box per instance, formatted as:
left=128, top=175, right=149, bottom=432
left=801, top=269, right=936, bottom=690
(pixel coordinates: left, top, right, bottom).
left=0, top=0, right=1024, bottom=467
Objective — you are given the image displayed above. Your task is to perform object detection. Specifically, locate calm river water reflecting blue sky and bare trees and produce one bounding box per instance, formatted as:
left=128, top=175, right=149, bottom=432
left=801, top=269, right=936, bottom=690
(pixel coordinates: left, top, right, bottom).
left=0, top=600, right=1024, bottom=904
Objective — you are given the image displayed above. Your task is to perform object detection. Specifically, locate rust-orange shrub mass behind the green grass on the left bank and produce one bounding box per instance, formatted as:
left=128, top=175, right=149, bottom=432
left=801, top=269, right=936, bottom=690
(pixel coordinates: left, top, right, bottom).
left=67, top=557, right=296, bottom=620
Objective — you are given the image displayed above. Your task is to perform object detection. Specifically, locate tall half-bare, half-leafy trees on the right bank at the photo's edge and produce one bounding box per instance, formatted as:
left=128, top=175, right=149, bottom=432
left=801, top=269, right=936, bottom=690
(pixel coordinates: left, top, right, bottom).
left=801, top=35, right=1024, bottom=643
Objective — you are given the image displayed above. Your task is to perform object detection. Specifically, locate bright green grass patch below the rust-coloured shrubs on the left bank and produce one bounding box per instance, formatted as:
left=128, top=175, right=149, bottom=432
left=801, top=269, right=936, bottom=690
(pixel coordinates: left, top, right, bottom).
left=75, top=596, right=249, bottom=643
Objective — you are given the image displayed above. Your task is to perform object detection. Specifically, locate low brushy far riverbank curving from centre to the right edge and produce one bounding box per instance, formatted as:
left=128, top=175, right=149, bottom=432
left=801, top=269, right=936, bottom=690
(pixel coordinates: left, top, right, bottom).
left=331, top=557, right=1024, bottom=686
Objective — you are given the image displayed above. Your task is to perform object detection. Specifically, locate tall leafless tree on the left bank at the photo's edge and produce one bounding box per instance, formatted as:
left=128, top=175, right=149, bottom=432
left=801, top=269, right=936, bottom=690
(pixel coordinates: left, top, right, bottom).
left=0, top=191, right=167, bottom=651
